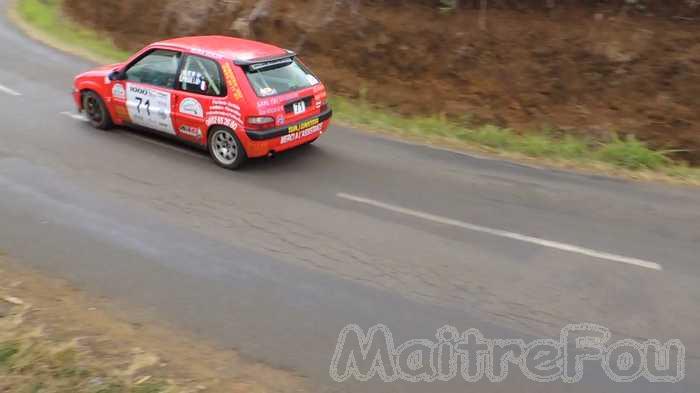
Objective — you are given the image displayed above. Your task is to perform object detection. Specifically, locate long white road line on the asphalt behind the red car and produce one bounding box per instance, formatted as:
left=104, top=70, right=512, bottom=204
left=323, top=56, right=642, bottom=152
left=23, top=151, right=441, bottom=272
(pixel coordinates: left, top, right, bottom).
left=336, top=193, right=663, bottom=271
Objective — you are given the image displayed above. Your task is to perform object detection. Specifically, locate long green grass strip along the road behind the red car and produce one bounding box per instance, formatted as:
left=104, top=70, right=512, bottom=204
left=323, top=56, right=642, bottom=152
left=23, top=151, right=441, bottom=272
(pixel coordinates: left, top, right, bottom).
left=331, top=97, right=700, bottom=182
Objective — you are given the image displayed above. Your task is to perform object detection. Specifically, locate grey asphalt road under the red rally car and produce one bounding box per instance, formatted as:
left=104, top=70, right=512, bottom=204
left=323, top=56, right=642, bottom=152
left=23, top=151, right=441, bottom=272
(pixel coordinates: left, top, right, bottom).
left=0, top=2, right=700, bottom=392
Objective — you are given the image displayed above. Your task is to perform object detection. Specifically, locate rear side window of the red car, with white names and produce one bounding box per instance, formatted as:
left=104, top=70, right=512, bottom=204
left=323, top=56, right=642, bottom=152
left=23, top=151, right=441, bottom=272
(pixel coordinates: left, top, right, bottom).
left=177, top=55, right=226, bottom=97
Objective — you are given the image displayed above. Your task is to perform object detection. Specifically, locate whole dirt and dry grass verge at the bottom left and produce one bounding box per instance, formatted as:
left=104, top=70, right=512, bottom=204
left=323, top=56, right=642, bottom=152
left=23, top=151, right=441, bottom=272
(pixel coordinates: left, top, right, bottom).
left=0, top=252, right=308, bottom=393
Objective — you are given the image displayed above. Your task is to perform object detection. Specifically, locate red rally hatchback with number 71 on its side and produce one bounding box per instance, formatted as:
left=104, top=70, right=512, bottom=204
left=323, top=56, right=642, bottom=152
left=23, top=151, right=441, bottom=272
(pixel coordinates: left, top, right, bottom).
left=73, top=36, right=332, bottom=169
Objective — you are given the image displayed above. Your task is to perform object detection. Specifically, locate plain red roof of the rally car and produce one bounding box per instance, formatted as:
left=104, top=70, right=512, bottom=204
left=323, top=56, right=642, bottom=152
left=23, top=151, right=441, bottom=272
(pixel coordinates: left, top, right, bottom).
left=153, top=35, right=290, bottom=61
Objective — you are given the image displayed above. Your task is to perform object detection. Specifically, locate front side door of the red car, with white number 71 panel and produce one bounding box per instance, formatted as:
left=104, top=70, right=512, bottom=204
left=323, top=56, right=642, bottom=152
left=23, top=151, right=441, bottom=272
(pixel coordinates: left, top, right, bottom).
left=123, top=49, right=182, bottom=135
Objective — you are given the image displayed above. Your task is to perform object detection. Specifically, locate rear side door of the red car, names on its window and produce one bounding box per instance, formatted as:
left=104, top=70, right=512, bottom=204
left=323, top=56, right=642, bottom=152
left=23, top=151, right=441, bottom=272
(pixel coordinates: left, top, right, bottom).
left=173, top=54, right=227, bottom=144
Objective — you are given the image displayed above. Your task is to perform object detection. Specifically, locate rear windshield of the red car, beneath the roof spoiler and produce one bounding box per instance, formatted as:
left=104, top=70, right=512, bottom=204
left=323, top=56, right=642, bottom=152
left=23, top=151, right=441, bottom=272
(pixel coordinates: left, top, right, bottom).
left=245, top=58, right=319, bottom=97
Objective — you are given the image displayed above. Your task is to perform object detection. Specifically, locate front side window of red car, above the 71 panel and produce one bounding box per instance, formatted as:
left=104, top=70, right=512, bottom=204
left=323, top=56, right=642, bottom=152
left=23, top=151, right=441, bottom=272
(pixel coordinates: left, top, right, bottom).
left=126, top=49, right=180, bottom=88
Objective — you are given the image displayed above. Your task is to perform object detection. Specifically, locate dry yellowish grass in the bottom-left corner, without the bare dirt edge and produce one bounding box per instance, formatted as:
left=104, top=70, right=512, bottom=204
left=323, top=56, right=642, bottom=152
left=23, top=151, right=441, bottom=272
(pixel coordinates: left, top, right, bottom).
left=0, top=282, right=175, bottom=393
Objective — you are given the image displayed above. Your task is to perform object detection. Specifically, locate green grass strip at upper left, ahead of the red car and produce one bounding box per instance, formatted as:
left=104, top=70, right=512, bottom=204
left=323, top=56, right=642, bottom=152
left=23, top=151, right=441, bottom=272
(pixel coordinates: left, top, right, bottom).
left=17, top=0, right=129, bottom=61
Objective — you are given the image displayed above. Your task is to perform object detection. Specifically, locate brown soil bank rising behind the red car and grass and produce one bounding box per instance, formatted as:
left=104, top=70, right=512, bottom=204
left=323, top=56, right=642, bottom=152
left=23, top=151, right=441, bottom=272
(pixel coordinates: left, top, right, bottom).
left=65, top=0, right=700, bottom=165
